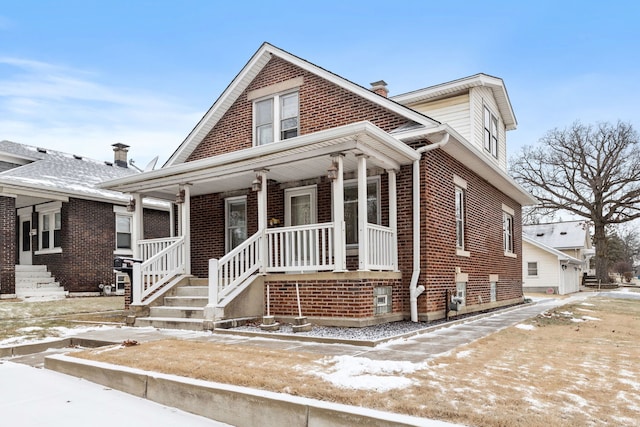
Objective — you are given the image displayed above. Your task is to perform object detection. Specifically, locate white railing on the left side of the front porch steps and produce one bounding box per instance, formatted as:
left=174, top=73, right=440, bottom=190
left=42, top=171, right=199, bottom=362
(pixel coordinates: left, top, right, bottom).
left=133, top=237, right=185, bottom=304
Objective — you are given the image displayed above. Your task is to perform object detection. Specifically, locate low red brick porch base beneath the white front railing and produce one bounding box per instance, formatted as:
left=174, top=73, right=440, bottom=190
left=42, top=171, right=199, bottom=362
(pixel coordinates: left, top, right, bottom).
left=265, top=275, right=402, bottom=318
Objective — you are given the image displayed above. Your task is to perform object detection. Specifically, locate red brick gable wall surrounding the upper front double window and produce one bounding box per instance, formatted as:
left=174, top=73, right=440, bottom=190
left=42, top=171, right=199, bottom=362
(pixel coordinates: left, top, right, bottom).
left=187, top=57, right=407, bottom=161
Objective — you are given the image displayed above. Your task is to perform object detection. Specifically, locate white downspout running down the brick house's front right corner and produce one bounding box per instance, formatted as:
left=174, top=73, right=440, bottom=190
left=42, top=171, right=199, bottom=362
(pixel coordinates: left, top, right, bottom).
left=409, top=133, right=449, bottom=322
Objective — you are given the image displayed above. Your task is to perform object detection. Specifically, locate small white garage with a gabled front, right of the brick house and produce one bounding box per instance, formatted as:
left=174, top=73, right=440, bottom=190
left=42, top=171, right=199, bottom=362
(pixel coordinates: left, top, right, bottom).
left=522, top=234, right=582, bottom=295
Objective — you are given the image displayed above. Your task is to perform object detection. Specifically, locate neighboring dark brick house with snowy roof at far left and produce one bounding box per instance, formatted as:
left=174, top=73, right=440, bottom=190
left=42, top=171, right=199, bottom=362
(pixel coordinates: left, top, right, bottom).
left=0, top=141, right=170, bottom=298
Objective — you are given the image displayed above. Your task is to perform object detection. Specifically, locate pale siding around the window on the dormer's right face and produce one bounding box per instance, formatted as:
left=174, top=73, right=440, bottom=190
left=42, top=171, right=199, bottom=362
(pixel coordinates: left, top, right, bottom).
left=469, top=87, right=507, bottom=170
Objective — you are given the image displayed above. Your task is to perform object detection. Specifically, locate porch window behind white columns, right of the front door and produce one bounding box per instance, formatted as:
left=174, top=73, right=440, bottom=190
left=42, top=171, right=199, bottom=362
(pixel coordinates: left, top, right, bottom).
left=344, top=176, right=381, bottom=246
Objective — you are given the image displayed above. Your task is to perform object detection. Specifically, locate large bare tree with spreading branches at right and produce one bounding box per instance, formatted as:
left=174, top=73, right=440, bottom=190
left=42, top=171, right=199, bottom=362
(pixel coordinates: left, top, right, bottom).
left=510, top=122, right=640, bottom=282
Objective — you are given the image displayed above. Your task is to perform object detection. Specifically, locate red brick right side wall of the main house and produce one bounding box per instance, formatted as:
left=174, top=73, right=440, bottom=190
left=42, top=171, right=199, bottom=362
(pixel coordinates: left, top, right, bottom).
left=416, top=150, right=522, bottom=313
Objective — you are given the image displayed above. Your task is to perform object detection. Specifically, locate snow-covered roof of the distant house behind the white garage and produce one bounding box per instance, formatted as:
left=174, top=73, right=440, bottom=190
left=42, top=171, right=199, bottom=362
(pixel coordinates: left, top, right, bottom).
left=522, top=221, right=591, bottom=250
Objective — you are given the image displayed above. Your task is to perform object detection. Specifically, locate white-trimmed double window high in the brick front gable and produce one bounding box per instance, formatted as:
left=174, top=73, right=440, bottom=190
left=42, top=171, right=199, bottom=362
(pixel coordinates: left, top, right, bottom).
left=253, top=91, right=299, bottom=145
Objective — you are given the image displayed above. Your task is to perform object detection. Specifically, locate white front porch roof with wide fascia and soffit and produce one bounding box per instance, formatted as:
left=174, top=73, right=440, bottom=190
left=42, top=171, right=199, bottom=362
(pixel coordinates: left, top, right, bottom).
left=101, top=121, right=420, bottom=200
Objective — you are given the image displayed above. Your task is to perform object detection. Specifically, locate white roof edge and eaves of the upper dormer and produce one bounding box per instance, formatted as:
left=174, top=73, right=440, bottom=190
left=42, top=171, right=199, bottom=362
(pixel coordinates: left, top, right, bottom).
left=391, top=73, right=518, bottom=130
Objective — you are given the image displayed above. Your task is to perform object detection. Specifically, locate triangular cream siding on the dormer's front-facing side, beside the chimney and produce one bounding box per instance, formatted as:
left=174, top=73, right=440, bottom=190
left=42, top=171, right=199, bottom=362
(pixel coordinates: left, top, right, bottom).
left=411, top=94, right=471, bottom=141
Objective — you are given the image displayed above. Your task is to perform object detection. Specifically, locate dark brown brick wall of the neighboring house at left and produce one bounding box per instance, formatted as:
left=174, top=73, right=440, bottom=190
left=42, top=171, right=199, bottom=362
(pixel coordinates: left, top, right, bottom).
left=33, top=199, right=169, bottom=292
